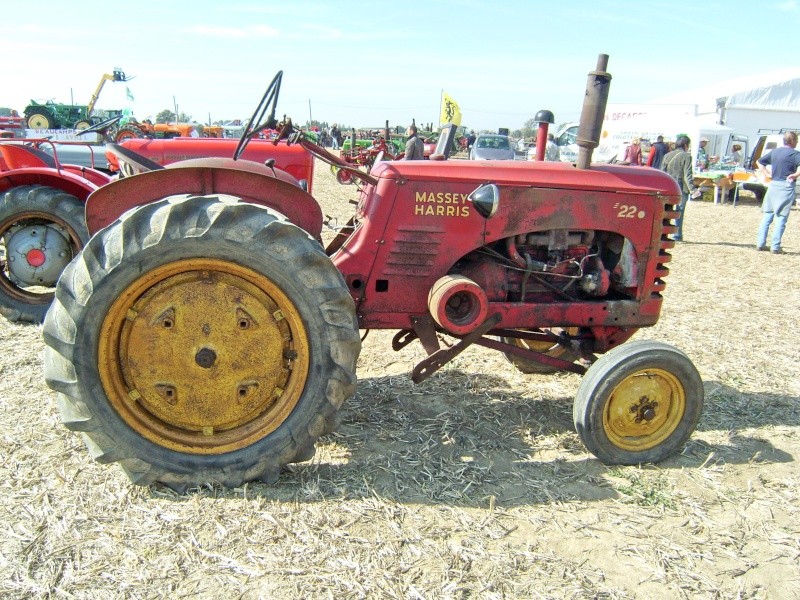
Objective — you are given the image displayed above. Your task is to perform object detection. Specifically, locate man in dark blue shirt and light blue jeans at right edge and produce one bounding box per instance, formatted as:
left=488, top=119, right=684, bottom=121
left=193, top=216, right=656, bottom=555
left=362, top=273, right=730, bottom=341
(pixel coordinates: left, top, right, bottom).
left=756, top=131, right=800, bottom=254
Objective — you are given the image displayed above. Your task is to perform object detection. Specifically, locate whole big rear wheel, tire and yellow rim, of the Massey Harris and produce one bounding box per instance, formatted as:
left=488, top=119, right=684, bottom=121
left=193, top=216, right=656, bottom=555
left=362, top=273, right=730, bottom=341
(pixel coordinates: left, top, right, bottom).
left=44, top=195, right=361, bottom=490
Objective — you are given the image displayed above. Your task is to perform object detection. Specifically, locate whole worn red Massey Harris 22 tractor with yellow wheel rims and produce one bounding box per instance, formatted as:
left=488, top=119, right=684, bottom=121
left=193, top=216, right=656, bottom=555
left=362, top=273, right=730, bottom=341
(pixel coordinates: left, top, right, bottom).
left=44, top=55, right=703, bottom=490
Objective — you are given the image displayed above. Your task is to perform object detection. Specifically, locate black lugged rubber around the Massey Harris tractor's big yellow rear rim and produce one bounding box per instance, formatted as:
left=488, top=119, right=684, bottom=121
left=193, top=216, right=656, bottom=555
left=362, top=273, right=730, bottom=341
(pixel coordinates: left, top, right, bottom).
left=44, top=195, right=361, bottom=490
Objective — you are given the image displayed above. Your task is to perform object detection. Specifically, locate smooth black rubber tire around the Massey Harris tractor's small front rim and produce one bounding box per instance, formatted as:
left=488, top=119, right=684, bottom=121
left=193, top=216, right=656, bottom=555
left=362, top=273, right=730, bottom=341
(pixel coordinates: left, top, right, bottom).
left=573, top=340, right=704, bottom=465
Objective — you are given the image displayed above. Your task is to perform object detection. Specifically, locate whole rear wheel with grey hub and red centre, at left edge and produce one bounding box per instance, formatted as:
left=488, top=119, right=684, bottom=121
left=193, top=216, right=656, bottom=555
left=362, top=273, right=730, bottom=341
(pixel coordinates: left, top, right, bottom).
left=0, top=185, right=89, bottom=323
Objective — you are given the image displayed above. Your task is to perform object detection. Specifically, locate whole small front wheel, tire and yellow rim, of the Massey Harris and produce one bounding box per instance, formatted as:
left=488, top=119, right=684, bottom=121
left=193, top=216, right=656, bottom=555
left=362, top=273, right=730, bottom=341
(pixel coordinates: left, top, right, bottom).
left=573, top=341, right=704, bottom=465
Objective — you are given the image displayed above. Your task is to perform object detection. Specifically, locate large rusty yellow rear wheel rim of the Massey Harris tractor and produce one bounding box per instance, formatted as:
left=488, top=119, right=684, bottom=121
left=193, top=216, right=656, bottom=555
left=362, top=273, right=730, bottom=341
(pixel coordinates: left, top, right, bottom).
left=98, top=259, right=309, bottom=454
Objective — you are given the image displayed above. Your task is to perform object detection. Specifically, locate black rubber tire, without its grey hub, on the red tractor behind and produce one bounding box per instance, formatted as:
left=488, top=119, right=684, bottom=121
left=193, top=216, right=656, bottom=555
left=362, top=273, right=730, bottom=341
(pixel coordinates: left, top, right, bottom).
left=0, top=185, right=89, bottom=323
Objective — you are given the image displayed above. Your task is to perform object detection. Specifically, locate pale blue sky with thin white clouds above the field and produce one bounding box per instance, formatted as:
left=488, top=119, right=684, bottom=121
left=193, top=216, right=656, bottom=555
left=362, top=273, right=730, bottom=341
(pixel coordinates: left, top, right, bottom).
left=0, top=0, right=800, bottom=129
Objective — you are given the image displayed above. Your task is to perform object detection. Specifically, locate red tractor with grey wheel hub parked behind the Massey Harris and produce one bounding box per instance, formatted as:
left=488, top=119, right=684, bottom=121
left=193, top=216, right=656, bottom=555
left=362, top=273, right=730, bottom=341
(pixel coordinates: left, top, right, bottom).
left=0, top=117, right=314, bottom=323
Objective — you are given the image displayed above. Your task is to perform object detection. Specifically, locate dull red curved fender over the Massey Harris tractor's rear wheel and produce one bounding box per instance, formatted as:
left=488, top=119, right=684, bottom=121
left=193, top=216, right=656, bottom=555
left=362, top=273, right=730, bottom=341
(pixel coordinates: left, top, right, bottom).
left=86, top=164, right=322, bottom=241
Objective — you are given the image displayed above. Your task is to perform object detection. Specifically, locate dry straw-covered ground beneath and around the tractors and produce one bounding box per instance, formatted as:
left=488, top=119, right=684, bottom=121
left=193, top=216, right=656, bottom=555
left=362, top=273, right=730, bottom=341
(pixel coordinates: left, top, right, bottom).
left=0, top=165, right=800, bottom=600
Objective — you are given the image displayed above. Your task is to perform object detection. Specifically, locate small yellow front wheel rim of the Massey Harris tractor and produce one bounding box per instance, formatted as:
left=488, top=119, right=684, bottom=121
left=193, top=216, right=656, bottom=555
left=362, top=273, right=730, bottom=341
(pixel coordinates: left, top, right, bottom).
left=603, top=369, right=686, bottom=452
